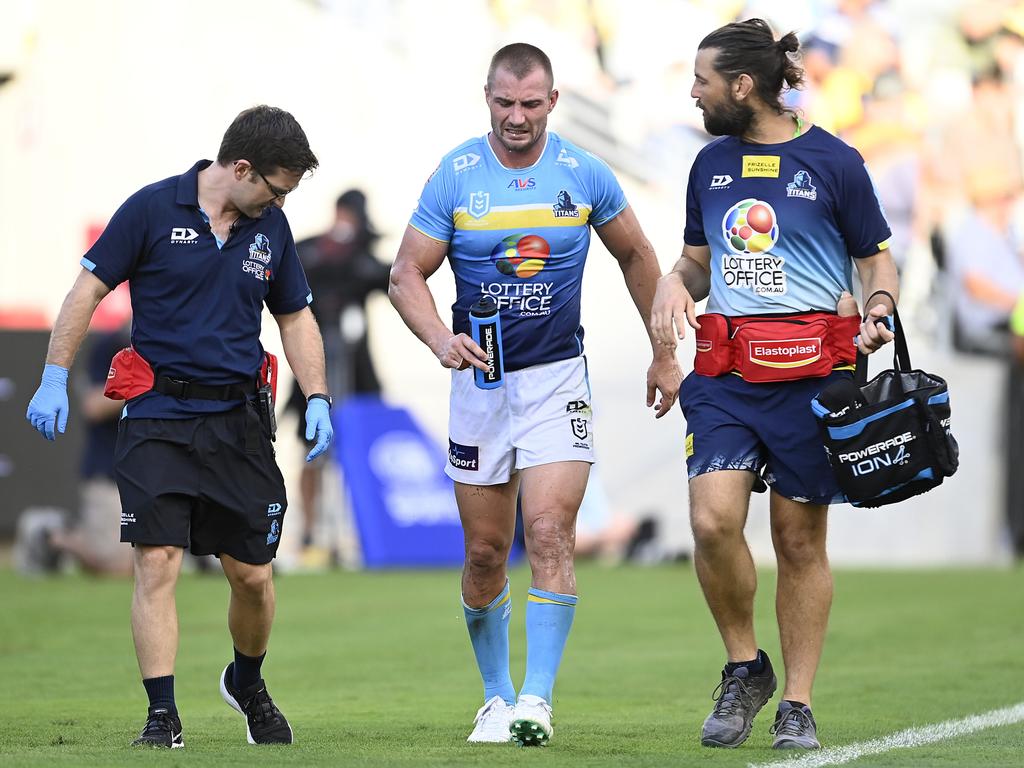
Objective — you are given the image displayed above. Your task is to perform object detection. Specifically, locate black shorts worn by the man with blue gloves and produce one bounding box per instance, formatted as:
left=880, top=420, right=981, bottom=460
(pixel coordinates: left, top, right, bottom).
left=115, top=402, right=288, bottom=565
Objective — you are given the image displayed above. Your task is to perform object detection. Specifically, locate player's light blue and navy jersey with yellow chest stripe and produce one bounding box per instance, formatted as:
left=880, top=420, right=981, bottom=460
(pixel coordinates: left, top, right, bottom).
left=410, top=132, right=626, bottom=371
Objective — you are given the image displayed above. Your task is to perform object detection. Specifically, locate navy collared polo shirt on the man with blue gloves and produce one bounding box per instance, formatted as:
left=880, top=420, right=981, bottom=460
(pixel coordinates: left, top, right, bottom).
left=82, top=160, right=312, bottom=419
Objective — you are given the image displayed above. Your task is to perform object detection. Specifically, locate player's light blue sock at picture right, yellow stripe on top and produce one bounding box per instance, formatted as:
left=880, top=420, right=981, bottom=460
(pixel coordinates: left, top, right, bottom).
left=519, top=587, right=577, bottom=703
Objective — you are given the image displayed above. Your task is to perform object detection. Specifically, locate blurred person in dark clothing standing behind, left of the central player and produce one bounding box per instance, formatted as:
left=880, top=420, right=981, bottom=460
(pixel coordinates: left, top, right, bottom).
left=286, top=189, right=391, bottom=565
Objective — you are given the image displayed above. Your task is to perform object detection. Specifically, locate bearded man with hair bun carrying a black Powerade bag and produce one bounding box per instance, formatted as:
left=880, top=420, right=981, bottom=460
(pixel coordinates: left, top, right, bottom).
left=652, top=18, right=898, bottom=749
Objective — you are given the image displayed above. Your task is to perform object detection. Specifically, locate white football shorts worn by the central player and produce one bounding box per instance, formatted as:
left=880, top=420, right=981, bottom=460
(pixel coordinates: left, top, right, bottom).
left=444, top=355, right=594, bottom=485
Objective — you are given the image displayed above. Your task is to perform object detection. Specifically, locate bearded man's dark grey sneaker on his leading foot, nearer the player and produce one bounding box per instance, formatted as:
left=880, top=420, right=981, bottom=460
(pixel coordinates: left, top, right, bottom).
left=700, top=650, right=776, bottom=748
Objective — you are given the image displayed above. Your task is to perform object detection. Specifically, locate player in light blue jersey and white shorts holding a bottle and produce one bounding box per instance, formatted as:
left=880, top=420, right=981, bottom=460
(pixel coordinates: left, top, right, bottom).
left=389, top=43, right=681, bottom=745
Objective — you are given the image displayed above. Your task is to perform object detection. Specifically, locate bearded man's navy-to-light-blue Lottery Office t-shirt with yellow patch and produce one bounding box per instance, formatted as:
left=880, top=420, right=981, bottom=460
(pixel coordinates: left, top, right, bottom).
left=685, top=126, right=890, bottom=315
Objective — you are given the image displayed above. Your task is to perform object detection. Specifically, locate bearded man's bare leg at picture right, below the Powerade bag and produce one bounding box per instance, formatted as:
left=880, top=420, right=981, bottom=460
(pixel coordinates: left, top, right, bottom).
left=771, top=490, right=833, bottom=707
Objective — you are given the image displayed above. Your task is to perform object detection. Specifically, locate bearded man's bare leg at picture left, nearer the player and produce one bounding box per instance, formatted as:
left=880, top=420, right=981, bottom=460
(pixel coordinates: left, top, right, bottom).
left=689, top=470, right=758, bottom=663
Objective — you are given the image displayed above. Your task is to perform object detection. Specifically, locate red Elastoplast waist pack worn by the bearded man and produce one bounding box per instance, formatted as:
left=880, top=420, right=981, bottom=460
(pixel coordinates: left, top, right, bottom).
left=693, top=312, right=860, bottom=383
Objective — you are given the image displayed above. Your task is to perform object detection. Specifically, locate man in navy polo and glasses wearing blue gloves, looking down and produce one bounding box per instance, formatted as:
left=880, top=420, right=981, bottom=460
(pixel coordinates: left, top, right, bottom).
left=27, top=105, right=333, bottom=748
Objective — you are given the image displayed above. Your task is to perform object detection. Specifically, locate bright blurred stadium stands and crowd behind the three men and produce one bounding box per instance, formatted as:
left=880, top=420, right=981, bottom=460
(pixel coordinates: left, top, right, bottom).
left=0, top=0, right=1024, bottom=564
